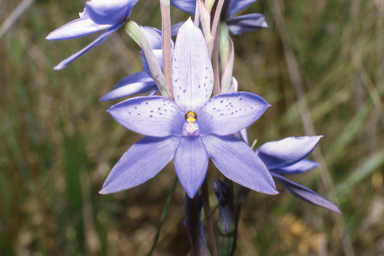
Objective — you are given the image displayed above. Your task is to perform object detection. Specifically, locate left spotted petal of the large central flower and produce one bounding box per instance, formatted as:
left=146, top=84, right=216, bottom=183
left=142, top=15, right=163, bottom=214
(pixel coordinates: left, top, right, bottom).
left=108, top=96, right=184, bottom=137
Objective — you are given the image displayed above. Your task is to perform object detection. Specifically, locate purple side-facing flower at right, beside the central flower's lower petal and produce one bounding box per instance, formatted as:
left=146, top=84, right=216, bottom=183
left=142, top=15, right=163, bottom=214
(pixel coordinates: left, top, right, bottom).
left=256, top=136, right=340, bottom=213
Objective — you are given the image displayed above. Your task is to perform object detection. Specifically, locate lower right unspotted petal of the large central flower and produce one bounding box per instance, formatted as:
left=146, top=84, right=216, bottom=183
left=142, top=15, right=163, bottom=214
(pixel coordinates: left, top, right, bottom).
left=201, top=135, right=278, bottom=194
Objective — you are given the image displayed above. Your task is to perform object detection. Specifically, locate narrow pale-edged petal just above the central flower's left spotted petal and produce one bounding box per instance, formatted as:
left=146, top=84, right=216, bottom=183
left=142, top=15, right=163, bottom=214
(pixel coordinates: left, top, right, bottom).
left=100, top=79, right=157, bottom=101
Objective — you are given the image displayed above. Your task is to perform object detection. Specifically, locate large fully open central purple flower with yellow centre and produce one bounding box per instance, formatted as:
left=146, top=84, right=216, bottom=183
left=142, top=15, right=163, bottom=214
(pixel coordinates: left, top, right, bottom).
left=100, top=20, right=277, bottom=198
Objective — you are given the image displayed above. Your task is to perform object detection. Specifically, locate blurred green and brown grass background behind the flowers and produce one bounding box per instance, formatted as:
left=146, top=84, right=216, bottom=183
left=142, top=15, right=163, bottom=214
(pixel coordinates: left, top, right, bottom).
left=0, top=0, right=384, bottom=256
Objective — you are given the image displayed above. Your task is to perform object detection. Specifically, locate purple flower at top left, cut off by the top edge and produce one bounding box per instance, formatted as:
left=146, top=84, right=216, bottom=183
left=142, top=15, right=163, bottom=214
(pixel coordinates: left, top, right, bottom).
left=46, top=0, right=138, bottom=70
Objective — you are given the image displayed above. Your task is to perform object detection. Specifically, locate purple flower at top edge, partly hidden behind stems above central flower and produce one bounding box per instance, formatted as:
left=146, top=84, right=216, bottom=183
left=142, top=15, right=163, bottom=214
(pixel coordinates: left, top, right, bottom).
left=171, top=0, right=268, bottom=35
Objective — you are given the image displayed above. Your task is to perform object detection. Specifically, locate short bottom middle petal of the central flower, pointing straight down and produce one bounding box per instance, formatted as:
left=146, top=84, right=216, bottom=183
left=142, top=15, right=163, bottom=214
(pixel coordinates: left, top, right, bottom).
left=174, top=137, right=209, bottom=198
